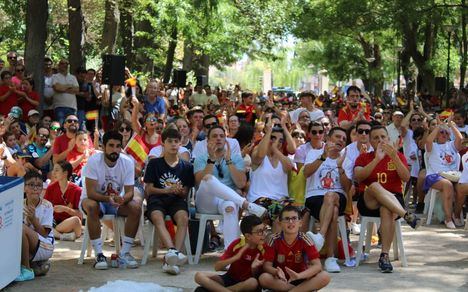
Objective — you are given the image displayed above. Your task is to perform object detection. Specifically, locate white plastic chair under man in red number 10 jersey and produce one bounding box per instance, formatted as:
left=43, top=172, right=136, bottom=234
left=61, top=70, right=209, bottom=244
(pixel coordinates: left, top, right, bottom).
left=356, top=216, right=408, bottom=267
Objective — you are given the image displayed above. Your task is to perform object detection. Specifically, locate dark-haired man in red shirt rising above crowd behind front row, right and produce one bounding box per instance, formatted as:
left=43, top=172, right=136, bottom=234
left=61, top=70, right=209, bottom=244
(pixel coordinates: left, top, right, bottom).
left=338, top=85, right=370, bottom=129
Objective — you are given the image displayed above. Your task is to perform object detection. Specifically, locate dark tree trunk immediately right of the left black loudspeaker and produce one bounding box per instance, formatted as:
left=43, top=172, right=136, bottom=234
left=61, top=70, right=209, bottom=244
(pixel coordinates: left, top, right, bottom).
left=119, top=0, right=135, bottom=68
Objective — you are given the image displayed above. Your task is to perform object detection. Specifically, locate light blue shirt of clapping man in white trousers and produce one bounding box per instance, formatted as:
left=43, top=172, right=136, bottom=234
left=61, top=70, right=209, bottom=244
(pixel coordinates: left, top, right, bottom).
left=193, top=153, right=245, bottom=190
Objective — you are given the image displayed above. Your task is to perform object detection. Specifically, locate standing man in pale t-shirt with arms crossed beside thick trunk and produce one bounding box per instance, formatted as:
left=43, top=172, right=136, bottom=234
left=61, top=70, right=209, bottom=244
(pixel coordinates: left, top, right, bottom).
left=52, top=59, right=79, bottom=124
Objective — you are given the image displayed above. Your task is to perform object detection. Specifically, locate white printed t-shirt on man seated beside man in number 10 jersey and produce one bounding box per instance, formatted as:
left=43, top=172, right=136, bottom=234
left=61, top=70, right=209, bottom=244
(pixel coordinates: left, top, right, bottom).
left=305, top=149, right=345, bottom=199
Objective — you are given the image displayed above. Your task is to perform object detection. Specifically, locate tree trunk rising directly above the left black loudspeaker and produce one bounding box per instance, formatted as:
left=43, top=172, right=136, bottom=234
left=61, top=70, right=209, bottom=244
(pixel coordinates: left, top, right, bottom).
left=101, top=0, right=120, bottom=54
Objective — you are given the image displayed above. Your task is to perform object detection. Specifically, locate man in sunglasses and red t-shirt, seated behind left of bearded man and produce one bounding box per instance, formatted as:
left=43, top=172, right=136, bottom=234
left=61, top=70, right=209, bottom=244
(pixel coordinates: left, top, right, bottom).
left=53, top=114, right=93, bottom=163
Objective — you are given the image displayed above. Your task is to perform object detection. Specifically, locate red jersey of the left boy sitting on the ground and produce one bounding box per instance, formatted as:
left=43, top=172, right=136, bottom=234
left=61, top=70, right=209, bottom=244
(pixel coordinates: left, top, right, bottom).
left=220, top=238, right=262, bottom=282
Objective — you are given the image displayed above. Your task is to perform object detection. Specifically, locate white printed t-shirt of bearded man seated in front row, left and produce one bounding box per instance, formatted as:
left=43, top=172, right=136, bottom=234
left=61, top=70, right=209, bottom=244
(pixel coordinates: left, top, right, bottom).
left=81, top=151, right=135, bottom=200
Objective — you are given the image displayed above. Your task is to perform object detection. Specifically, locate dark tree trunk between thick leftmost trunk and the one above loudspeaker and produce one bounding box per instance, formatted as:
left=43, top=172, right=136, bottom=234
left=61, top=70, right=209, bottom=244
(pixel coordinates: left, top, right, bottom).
left=68, top=0, right=86, bottom=73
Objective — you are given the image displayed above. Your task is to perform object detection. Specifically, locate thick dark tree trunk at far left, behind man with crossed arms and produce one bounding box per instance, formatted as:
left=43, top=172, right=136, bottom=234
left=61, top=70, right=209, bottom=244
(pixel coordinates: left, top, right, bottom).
left=24, top=0, right=49, bottom=112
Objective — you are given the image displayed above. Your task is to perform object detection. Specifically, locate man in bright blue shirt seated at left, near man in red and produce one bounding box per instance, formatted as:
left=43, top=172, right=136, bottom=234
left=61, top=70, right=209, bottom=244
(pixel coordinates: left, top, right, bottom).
left=27, top=126, right=52, bottom=180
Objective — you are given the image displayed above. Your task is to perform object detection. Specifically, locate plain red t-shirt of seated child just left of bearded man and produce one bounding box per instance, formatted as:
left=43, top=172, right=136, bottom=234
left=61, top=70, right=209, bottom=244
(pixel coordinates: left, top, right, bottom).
left=44, top=182, right=81, bottom=223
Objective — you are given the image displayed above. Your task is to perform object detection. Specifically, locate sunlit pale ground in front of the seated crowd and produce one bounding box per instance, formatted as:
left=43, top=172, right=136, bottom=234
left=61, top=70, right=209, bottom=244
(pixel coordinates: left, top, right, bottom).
left=6, top=225, right=468, bottom=292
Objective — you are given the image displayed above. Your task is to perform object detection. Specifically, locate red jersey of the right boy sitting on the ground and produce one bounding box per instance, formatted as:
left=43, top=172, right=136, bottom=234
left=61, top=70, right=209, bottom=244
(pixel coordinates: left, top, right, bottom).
left=264, top=232, right=320, bottom=279
